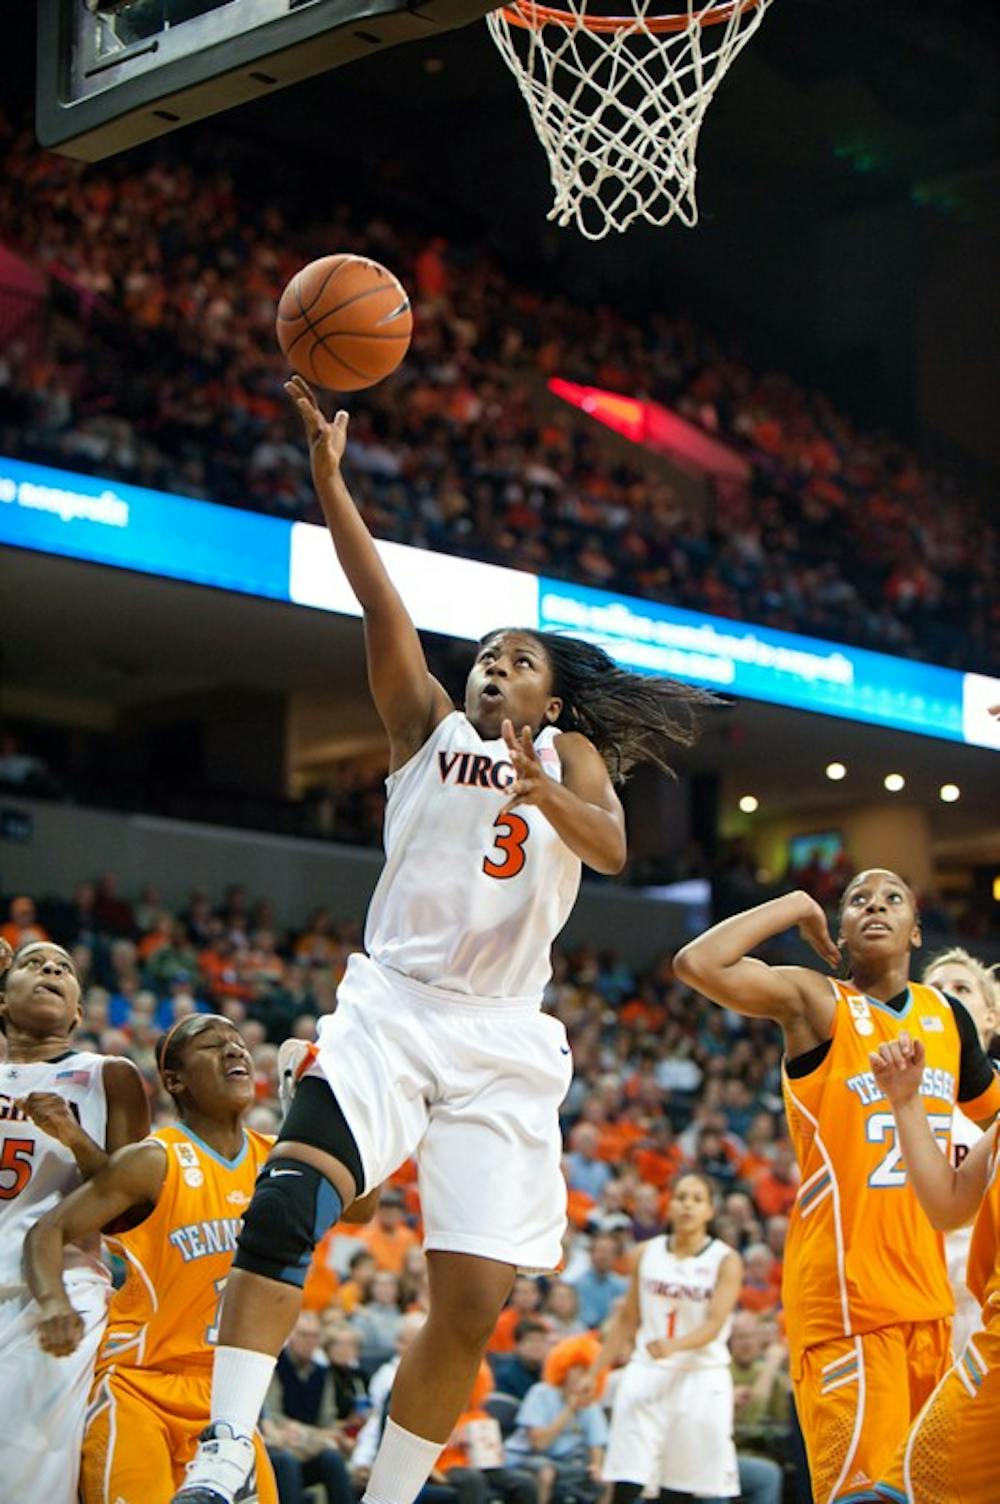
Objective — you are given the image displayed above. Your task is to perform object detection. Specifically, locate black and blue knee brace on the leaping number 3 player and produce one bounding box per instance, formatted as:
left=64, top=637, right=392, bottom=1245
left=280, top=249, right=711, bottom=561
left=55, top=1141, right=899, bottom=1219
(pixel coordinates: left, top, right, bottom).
left=233, top=1158, right=343, bottom=1287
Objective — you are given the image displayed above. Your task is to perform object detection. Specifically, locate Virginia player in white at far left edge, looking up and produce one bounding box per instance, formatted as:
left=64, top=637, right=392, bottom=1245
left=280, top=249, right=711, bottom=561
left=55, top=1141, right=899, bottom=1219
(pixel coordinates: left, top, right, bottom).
left=0, top=940, right=149, bottom=1504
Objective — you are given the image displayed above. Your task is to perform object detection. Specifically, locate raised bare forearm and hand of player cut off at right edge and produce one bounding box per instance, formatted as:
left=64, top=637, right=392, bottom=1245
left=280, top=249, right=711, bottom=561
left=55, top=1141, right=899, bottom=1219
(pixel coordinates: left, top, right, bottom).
left=869, top=1032, right=997, bottom=1232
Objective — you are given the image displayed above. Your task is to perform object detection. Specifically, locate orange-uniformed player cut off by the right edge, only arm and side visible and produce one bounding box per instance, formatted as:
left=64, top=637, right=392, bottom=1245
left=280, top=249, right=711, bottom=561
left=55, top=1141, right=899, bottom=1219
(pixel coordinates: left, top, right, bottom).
left=871, top=1032, right=1000, bottom=1504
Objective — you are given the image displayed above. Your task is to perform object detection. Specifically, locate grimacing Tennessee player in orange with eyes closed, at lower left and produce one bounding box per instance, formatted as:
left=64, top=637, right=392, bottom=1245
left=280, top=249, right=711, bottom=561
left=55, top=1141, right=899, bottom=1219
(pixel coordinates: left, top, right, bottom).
left=26, top=1014, right=277, bottom=1504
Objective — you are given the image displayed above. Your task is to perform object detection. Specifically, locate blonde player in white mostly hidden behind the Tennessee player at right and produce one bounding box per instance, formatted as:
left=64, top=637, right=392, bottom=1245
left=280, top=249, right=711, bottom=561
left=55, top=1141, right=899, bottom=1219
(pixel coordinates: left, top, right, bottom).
left=923, top=946, right=997, bottom=1354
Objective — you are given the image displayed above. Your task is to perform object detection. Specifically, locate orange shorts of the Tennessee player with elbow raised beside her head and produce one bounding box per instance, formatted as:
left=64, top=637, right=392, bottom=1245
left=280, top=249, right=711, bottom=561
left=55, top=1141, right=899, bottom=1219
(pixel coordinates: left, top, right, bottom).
left=792, top=1321, right=952, bottom=1504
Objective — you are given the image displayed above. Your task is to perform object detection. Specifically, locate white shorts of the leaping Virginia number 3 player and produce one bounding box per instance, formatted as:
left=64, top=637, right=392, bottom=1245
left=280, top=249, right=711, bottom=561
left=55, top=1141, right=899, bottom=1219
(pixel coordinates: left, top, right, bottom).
left=305, top=955, right=573, bottom=1271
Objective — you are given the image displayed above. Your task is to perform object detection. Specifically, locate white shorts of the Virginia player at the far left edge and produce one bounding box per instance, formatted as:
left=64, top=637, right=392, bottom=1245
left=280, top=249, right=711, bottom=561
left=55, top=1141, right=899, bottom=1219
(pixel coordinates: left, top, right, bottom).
left=0, top=1269, right=111, bottom=1504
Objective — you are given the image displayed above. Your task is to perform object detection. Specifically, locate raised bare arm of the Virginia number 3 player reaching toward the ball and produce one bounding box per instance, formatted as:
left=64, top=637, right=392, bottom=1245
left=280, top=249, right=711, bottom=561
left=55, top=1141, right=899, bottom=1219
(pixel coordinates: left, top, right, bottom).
left=284, top=376, right=454, bottom=767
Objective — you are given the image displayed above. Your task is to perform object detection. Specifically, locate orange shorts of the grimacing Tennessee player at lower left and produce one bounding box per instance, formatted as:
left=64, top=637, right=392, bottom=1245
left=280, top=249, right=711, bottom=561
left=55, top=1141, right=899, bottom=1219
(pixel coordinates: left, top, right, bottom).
left=80, top=1369, right=278, bottom=1504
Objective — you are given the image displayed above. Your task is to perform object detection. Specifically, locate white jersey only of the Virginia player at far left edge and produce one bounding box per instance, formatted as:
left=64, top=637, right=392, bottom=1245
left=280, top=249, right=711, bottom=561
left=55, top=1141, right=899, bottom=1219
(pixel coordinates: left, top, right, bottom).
left=0, top=1053, right=108, bottom=1289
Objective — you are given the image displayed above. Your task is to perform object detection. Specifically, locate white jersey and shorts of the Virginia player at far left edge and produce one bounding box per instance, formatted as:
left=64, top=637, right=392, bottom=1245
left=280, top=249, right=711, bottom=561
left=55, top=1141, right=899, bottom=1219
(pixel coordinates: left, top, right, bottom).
left=0, top=1051, right=111, bottom=1504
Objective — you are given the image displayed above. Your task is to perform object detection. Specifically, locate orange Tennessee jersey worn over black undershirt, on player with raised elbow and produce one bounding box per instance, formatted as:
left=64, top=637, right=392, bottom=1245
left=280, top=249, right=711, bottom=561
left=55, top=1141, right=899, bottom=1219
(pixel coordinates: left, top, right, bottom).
left=782, top=982, right=961, bottom=1363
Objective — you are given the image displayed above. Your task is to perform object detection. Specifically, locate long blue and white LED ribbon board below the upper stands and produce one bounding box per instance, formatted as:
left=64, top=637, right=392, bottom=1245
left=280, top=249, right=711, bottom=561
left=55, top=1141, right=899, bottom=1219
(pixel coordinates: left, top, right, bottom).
left=0, top=454, right=1000, bottom=752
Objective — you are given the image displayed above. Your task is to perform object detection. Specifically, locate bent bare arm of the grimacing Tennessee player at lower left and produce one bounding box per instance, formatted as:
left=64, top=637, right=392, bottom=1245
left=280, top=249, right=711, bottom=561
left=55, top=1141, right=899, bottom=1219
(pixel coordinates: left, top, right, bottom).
left=24, top=1140, right=167, bottom=1358
